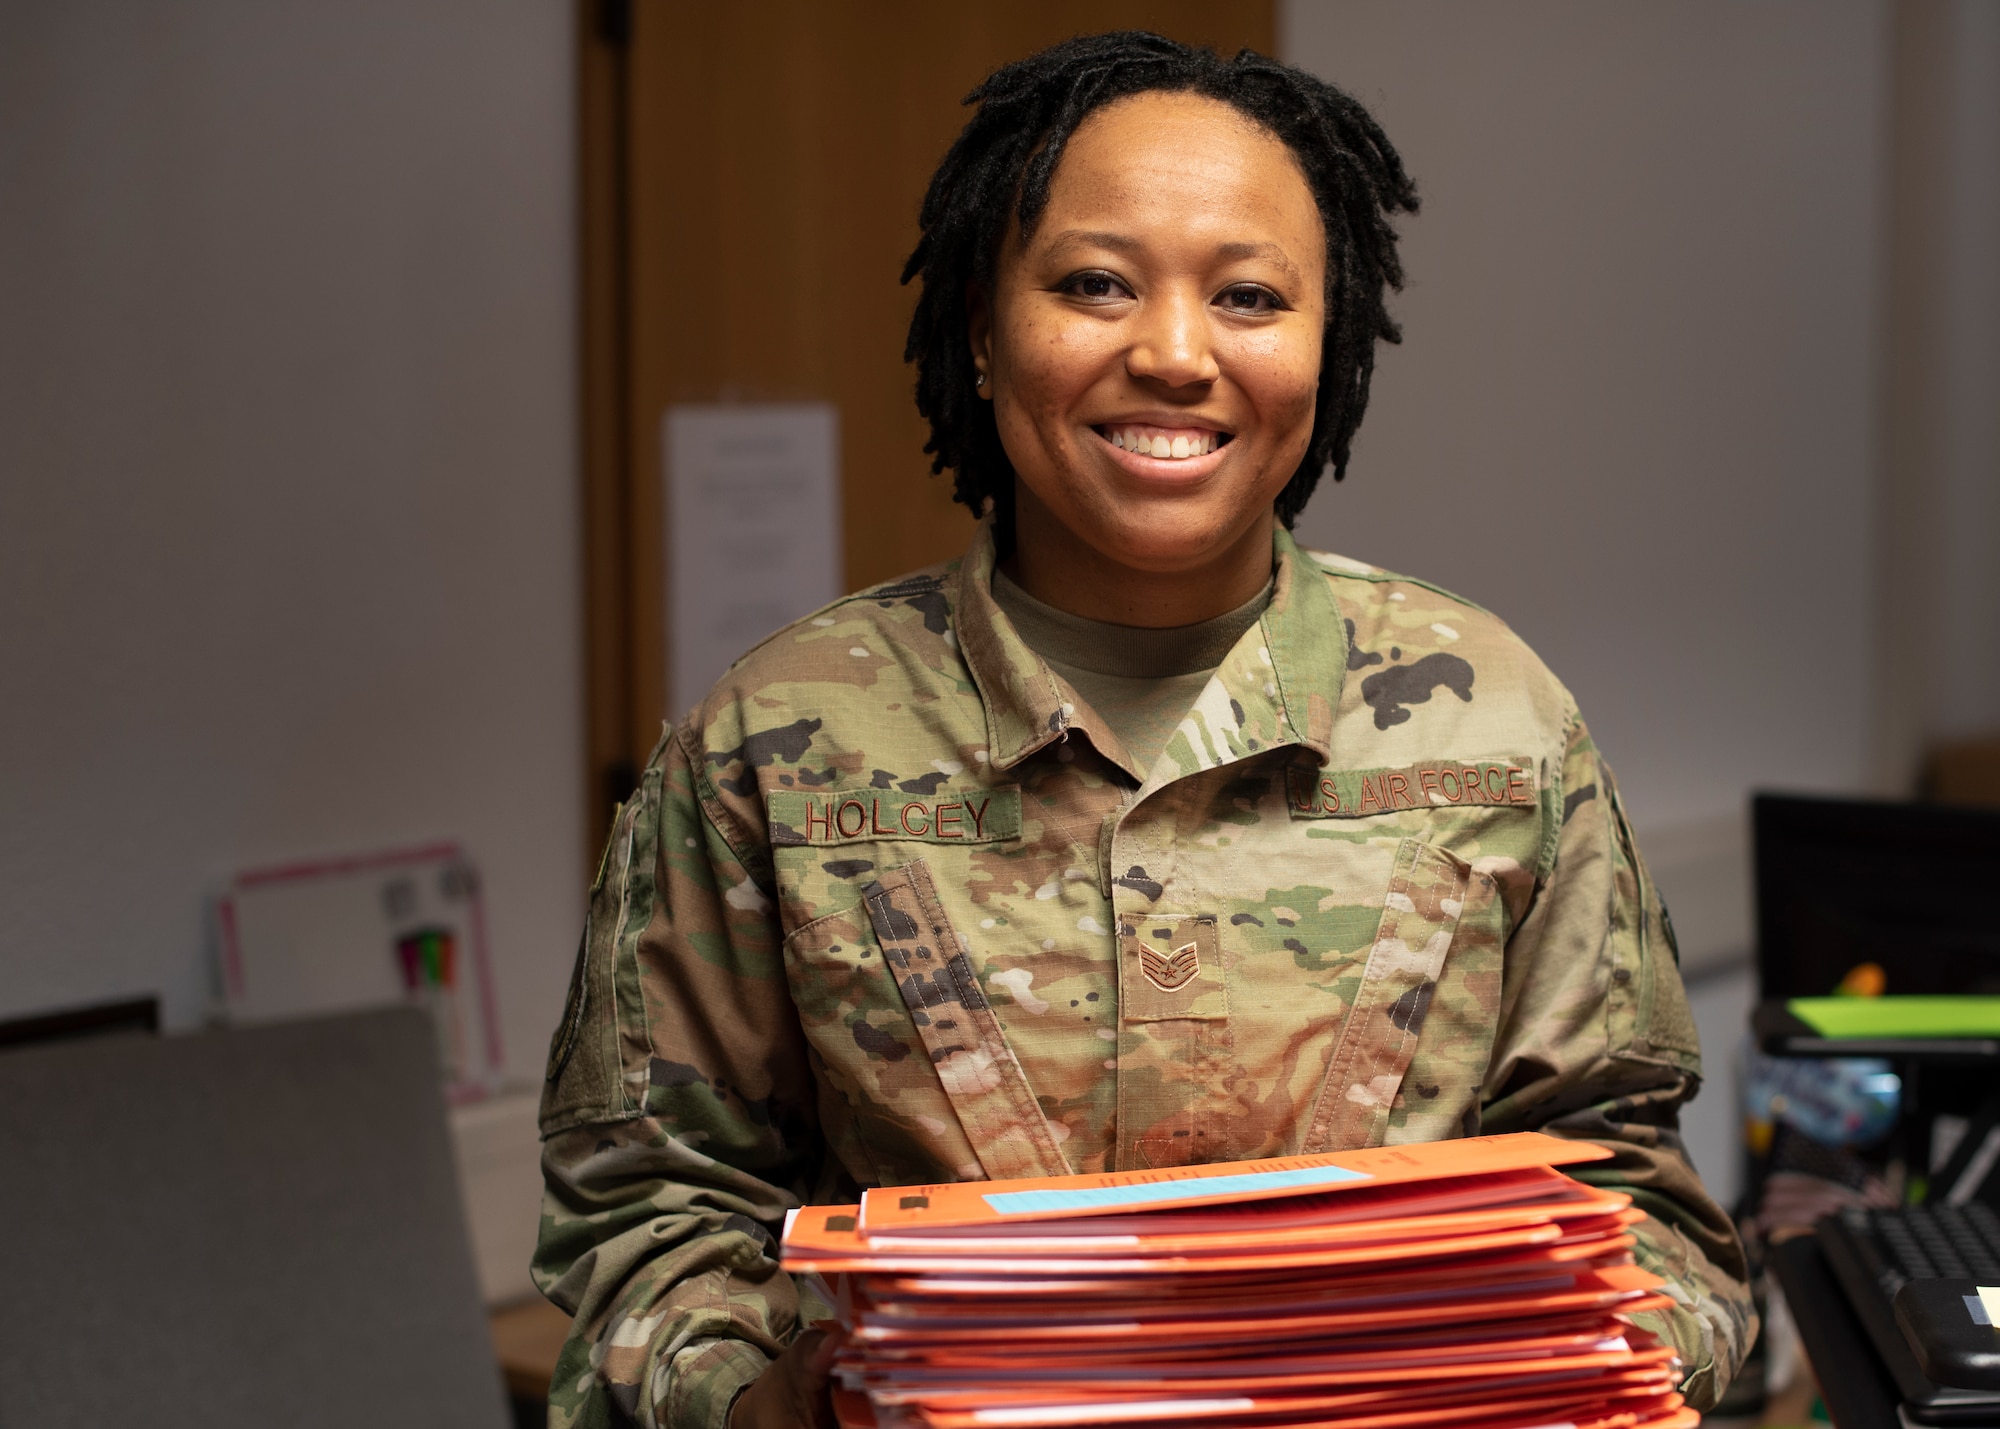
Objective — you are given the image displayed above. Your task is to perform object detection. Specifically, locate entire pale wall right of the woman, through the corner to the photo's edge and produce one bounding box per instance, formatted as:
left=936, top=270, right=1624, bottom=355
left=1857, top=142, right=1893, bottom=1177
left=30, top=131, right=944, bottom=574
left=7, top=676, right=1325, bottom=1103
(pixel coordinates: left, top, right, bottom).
left=1280, top=0, right=2000, bottom=1201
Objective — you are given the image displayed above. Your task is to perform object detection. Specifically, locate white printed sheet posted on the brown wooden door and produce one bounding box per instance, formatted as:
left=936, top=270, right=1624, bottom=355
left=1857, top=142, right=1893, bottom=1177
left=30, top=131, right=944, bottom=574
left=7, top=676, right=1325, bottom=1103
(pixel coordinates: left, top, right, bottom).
left=660, top=402, right=840, bottom=719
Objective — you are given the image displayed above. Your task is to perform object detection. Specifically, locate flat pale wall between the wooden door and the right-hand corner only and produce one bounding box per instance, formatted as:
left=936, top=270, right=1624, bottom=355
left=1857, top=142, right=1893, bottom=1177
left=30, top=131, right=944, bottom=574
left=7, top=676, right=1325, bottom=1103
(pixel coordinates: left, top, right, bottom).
left=1280, top=0, right=1890, bottom=844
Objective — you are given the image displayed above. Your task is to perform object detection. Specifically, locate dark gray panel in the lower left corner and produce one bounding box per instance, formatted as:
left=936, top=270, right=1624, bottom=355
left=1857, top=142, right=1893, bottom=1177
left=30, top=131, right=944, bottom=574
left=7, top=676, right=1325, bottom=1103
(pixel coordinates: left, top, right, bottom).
left=0, top=1011, right=508, bottom=1429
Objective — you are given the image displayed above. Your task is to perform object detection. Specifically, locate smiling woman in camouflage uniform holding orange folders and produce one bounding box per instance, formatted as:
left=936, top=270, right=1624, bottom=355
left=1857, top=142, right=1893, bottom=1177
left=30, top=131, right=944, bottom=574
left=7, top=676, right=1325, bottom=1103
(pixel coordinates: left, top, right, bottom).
left=536, top=34, right=1754, bottom=1429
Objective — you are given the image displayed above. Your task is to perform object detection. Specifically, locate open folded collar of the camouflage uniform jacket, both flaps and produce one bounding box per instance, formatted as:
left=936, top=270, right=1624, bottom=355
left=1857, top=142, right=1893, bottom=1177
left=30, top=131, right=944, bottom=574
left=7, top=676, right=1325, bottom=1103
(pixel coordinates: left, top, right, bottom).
left=952, top=520, right=1348, bottom=783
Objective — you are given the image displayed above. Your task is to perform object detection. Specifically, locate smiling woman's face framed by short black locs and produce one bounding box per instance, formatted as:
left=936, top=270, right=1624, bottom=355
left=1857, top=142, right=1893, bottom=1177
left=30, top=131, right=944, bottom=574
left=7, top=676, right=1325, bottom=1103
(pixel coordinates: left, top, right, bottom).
left=970, top=94, right=1326, bottom=588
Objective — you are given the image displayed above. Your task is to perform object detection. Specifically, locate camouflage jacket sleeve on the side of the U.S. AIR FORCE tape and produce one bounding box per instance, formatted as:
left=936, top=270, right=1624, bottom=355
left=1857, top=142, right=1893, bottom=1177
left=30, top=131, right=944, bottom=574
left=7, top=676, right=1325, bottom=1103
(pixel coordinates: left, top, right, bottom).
left=1480, top=717, right=1756, bottom=1411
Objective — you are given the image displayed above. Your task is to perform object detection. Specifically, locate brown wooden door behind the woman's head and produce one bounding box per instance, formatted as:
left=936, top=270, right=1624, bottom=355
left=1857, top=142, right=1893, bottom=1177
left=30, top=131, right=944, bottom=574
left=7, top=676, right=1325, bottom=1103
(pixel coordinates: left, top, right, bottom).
left=578, top=0, right=1276, bottom=857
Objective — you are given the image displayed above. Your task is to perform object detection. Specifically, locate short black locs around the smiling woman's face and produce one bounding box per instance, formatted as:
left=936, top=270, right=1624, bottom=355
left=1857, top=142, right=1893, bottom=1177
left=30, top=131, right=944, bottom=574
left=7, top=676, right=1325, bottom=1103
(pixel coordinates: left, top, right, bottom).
left=902, top=30, right=1416, bottom=546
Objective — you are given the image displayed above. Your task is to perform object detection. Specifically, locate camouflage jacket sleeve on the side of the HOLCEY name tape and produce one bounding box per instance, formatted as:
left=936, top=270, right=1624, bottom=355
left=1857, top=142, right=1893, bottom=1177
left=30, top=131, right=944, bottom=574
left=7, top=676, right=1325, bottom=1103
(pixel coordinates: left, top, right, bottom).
left=534, top=735, right=818, bottom=1429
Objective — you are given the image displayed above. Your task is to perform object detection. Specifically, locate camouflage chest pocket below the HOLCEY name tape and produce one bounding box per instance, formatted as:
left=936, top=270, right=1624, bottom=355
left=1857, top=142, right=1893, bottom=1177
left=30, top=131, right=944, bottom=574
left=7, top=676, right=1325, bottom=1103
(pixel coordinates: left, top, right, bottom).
left=786, top=859, right=1068, bottom=1183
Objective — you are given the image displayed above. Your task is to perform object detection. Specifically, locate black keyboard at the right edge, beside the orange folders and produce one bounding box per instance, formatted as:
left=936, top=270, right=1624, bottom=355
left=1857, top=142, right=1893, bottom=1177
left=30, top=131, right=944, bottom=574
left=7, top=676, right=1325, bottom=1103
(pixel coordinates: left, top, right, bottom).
left=1818, top=1201, right=2000, bottom=1425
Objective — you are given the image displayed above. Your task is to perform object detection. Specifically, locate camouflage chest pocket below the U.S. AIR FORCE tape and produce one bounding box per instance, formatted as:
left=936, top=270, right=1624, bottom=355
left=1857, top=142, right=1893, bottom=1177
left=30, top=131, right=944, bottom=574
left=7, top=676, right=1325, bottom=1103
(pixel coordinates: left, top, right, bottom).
left=1300, top=839, right=1502, bottom=1151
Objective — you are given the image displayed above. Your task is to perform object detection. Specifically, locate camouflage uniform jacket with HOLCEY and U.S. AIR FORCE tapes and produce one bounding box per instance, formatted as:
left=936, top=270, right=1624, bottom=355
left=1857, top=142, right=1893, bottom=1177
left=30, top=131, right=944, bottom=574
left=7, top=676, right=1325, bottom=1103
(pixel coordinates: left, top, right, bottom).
left=534, top=526, right=1754, bottom=1427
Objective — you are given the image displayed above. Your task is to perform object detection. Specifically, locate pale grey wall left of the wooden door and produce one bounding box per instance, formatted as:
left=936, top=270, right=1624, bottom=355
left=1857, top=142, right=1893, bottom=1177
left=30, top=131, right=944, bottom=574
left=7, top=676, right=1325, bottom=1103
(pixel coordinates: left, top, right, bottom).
left=0, top=0, right=584, bottom=1077
